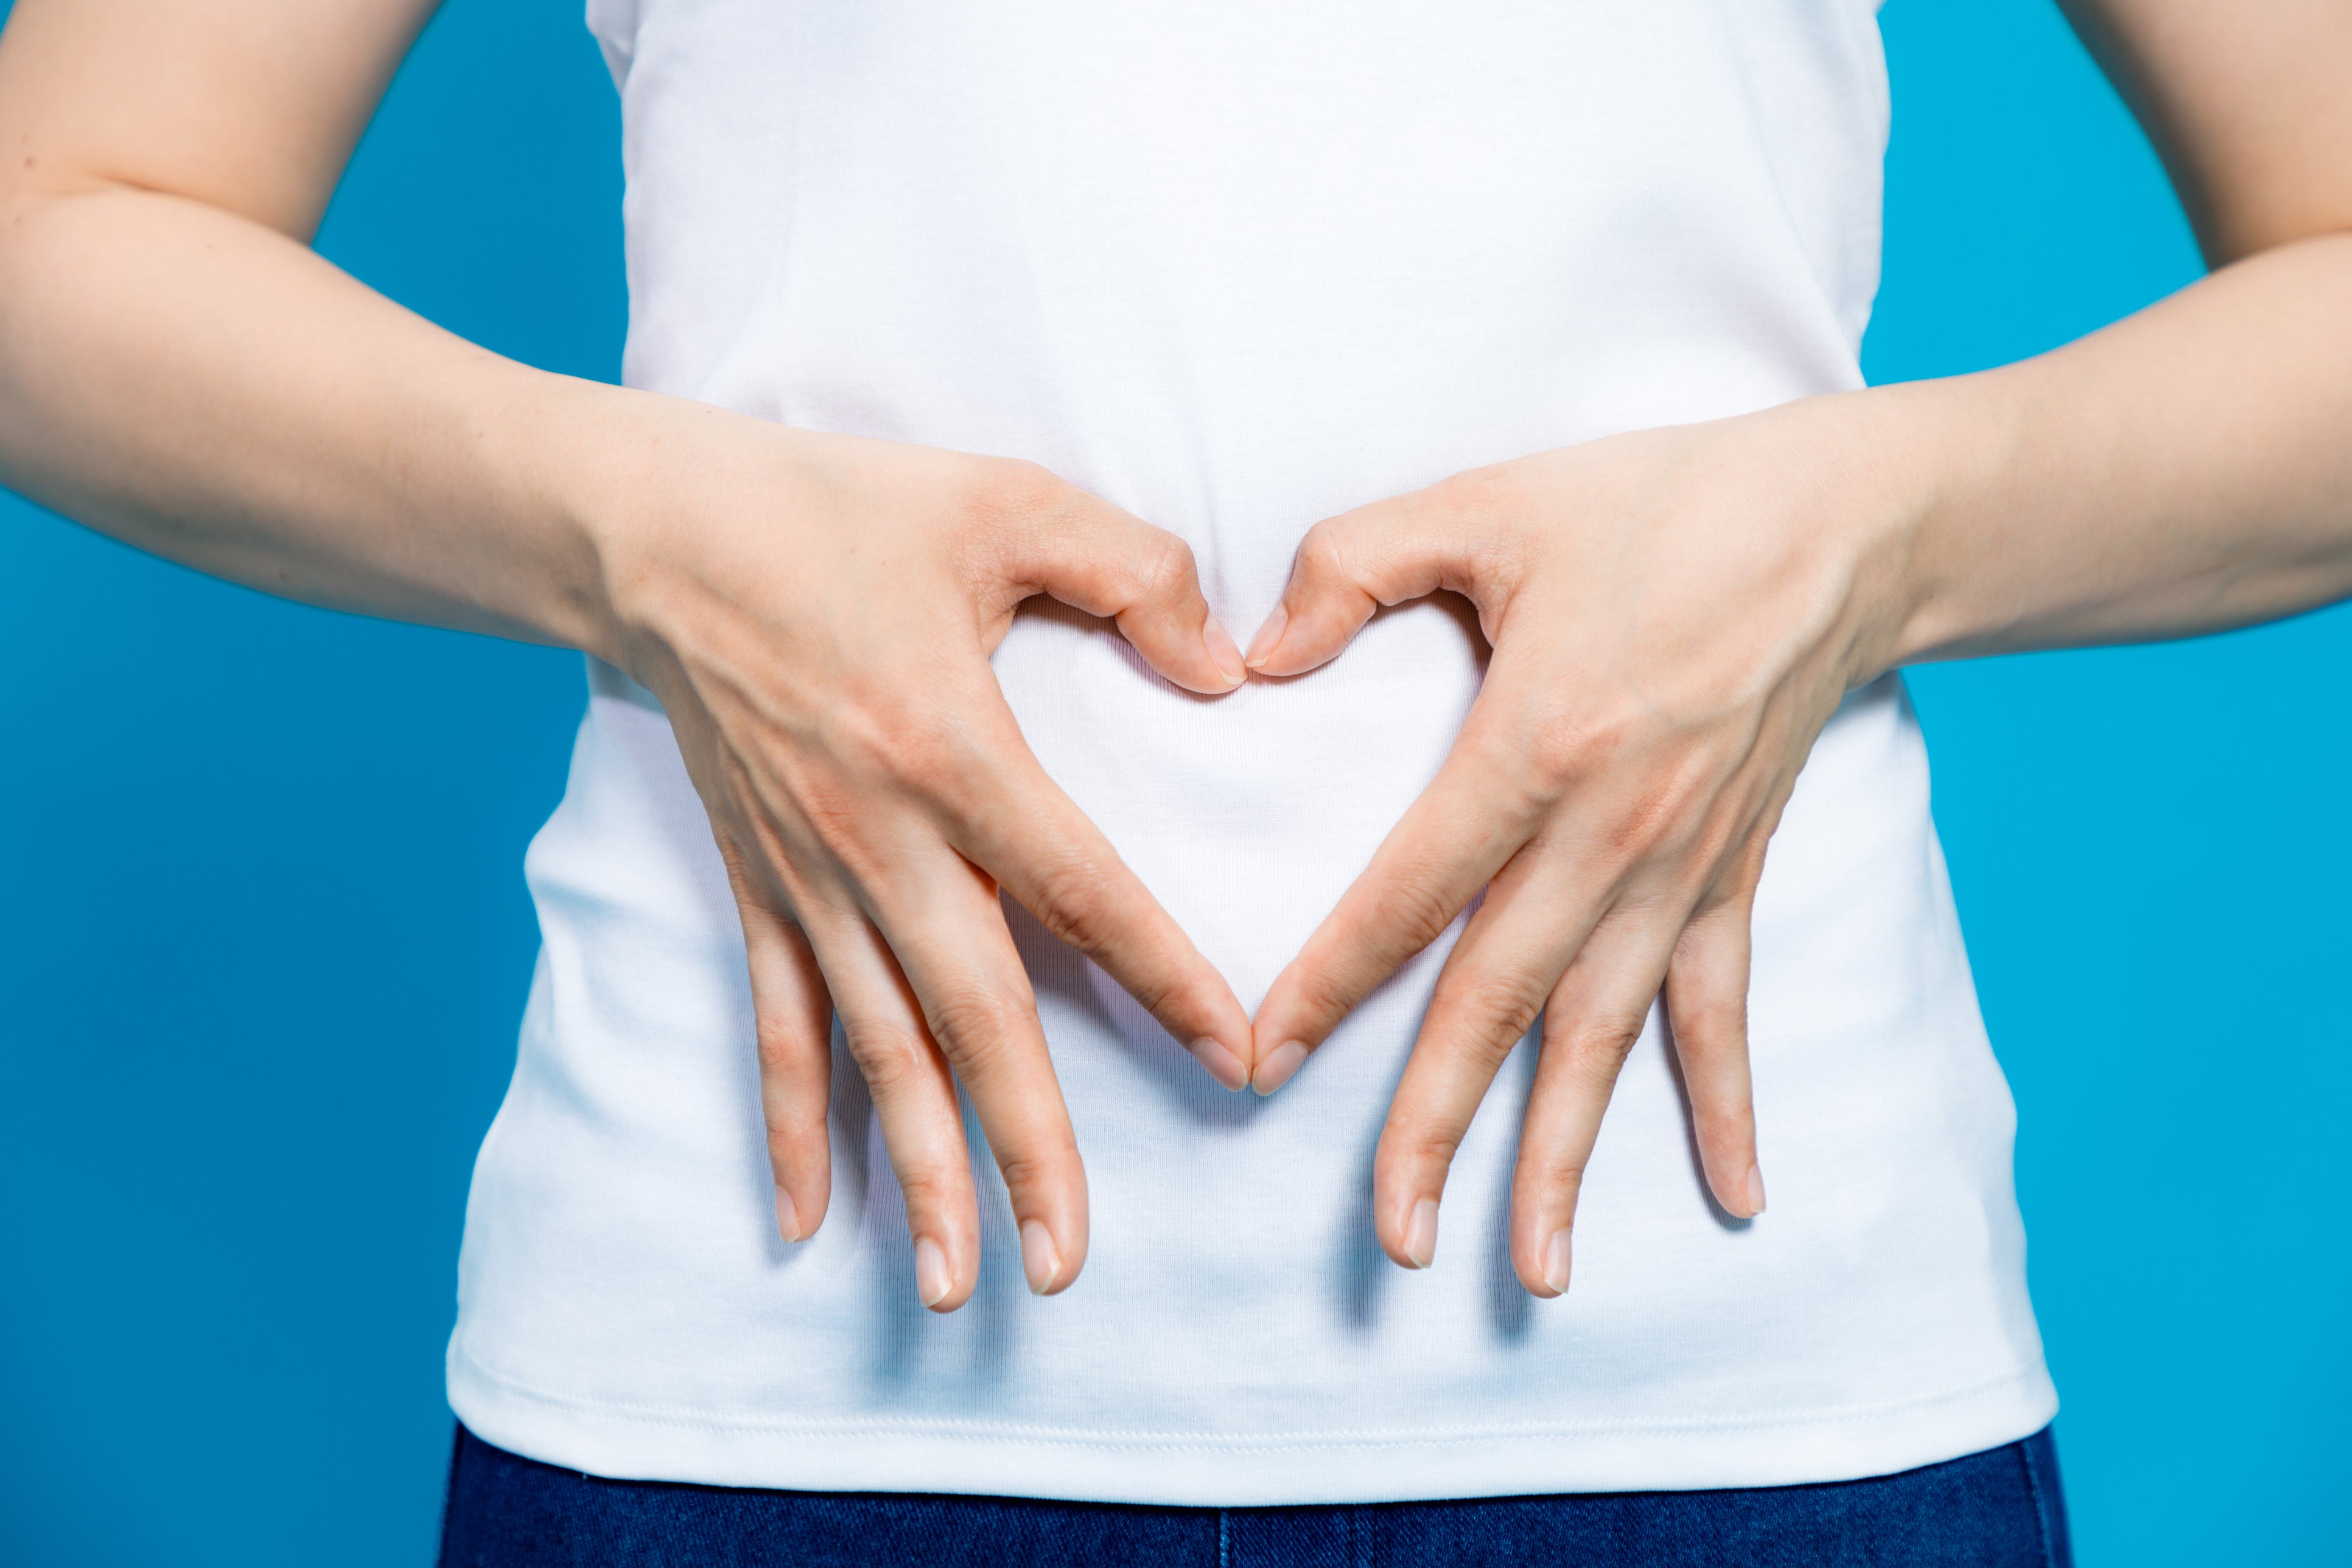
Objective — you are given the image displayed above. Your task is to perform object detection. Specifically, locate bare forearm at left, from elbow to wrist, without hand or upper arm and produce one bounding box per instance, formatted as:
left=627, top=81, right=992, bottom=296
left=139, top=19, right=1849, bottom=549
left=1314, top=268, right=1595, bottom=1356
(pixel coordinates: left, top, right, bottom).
left=0, top=183, right=632, bottom=646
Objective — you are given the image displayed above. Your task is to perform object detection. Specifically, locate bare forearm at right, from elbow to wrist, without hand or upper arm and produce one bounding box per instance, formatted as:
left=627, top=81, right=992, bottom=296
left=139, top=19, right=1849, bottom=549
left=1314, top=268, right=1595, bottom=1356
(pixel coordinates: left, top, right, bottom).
left=1858, top=235, right=2352, bottom=668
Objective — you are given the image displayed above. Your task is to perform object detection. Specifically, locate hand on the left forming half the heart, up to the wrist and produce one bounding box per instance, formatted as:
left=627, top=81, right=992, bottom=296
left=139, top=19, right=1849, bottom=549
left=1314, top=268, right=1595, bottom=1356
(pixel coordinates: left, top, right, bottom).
left=588, top=393, right=1251, bottom=1312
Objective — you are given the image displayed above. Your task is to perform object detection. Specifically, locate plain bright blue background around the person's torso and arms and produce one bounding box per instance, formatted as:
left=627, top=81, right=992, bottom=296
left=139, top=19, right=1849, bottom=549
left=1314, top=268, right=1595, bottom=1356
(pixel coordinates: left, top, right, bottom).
left=0, top=0, right=2352, bottom=1568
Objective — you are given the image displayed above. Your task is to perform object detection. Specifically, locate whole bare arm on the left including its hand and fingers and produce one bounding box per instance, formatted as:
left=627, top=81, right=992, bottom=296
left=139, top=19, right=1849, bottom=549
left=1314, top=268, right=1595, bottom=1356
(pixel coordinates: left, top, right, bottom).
left=0, top=0, right=1249, bottom=1312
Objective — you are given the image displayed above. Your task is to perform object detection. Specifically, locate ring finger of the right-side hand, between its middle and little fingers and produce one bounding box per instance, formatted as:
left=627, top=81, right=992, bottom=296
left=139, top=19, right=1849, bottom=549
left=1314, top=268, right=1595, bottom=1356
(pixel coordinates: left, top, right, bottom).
left=1510, top=905, right=1686, bottom=1298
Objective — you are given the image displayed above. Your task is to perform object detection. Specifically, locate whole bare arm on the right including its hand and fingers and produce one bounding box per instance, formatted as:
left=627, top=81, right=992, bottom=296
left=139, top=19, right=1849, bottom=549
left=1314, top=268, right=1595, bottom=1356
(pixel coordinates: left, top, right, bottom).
left=1249, top=0, right=2352, bottom=1295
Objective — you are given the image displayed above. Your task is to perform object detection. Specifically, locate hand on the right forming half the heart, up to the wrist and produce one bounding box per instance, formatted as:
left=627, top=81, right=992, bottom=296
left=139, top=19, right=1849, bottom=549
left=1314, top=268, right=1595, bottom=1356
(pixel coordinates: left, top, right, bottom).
left=1249, top=393, right=1917, bottom=1295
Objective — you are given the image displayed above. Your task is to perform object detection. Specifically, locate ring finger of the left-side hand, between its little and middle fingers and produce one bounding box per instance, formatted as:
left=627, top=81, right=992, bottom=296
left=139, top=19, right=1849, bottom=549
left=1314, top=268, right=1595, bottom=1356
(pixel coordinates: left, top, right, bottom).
left=795, top=900, right=981, bottom=1312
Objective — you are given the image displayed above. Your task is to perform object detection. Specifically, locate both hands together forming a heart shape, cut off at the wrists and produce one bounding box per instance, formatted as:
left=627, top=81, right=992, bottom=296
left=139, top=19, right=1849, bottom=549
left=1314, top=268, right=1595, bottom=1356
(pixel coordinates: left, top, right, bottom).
left=609, top=397, right=1898, bottom=1312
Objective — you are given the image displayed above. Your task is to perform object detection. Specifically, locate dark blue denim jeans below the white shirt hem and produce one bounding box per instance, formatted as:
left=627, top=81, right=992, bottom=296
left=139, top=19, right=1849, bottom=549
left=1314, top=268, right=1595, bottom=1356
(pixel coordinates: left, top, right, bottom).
left=440, top=1427, right=2074, bottom=1568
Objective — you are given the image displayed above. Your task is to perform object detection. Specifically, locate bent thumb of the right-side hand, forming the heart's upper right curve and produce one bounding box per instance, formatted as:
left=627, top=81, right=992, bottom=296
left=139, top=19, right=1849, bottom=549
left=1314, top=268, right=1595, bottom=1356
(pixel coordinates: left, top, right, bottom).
left=1242, top=491, right=1494, bottom=674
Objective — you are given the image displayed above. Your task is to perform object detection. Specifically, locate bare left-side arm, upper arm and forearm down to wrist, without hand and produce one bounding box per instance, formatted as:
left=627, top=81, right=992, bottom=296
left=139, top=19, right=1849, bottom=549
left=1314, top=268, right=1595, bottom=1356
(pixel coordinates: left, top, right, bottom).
left=0, top=0, right=616, bottom=654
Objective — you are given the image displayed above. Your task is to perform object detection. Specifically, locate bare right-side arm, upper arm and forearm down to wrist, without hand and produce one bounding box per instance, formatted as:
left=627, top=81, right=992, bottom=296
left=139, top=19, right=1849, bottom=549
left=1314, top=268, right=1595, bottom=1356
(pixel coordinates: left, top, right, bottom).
left=1875, top=0, right=2352, bottom=663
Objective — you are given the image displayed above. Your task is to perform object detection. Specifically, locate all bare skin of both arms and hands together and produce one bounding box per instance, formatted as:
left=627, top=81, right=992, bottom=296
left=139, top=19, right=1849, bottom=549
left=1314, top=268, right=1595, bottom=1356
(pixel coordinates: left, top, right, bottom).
left=0, top=0, right=2352, bottom=1312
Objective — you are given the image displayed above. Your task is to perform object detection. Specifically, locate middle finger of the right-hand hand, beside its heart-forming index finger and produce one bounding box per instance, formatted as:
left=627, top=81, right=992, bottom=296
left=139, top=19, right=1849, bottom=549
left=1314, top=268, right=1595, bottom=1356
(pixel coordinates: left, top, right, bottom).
left=1371, top=849, right=1627, bottom=1270
